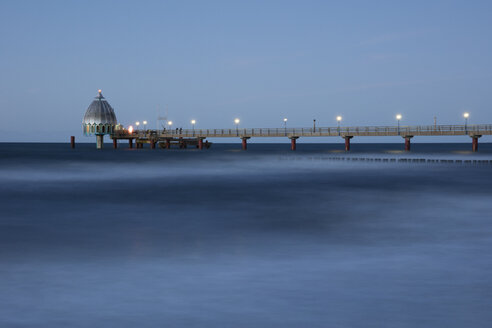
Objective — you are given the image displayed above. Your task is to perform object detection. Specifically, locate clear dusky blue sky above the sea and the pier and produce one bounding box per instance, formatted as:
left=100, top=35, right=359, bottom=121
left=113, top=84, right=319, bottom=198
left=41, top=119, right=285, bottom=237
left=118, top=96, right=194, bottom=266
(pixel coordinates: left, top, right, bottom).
left=0, top=0, right=492, bottom=142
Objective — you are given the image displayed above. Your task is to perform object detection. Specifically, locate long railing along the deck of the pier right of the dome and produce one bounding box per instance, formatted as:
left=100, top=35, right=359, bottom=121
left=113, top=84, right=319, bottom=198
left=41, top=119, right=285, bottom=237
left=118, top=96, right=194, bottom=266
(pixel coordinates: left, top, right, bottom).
left=114, top=124, right=492, bottom=139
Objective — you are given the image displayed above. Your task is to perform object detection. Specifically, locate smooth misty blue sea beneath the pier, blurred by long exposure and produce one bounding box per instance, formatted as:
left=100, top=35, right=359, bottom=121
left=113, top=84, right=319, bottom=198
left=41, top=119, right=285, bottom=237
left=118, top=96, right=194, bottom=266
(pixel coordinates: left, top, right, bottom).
left=0, top=143, right=492, bottom=328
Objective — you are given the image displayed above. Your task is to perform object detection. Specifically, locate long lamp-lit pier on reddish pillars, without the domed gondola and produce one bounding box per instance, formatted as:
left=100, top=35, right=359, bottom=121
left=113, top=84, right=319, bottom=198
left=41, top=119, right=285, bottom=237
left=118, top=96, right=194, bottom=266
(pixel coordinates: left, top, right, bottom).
left=111, top=124, right=492, bottom=151
